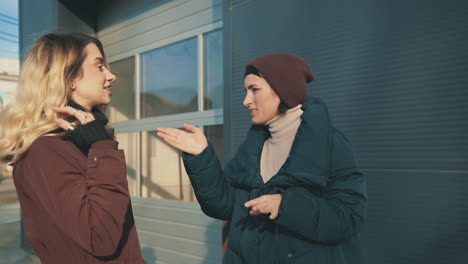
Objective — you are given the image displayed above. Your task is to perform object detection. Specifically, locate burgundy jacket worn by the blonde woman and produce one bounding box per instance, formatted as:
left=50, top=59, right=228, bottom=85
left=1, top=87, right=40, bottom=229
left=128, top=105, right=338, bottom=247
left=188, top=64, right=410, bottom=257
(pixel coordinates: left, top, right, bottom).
left=13, top=136, right=146, bottom=264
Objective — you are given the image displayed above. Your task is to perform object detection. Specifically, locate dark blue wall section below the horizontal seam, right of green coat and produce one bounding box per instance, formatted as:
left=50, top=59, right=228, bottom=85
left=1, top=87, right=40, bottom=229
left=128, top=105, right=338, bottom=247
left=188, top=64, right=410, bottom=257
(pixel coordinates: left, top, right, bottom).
left=363, top=171, right=468, bottom=264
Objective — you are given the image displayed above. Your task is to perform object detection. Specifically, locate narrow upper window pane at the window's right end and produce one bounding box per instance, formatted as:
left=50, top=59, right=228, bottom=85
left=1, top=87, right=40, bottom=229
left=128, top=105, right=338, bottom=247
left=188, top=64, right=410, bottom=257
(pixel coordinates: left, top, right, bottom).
left=203, top=30, right=223, bottom=110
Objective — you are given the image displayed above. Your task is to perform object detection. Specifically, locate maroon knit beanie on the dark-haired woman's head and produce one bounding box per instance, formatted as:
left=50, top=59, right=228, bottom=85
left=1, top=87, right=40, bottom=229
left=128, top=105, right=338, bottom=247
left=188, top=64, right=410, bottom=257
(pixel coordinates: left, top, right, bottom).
left=244, top=53, right=315, bottom=108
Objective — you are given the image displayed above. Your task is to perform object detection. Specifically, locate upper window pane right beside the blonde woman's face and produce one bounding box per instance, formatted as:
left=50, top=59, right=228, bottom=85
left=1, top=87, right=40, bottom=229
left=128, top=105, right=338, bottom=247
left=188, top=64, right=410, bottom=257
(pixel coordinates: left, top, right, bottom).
left=106, top=57, right=135, bottom=122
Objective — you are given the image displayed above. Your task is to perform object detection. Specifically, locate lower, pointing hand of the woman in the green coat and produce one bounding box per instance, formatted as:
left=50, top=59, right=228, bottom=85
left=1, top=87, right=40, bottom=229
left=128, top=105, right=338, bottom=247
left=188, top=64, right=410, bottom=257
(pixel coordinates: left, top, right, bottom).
left=244, top=194, right=282, bottom=220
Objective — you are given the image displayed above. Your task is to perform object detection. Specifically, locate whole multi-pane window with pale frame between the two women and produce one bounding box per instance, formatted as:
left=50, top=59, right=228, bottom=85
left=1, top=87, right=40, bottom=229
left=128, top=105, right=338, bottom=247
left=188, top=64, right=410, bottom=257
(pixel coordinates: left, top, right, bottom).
left=107, top=30, right=223, bottom=202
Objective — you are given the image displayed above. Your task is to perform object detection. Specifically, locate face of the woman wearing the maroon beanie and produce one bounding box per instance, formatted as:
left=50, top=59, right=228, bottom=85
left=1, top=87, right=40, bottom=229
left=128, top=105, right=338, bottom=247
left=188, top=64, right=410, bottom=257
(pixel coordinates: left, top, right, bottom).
left=243, top=74, right=281, bottom=125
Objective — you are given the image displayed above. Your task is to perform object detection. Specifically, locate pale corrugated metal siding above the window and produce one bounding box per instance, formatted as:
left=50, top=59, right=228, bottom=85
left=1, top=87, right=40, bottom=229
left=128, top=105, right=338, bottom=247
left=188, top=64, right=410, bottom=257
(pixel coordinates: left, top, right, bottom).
left=97, top=0, right=223, bottom=60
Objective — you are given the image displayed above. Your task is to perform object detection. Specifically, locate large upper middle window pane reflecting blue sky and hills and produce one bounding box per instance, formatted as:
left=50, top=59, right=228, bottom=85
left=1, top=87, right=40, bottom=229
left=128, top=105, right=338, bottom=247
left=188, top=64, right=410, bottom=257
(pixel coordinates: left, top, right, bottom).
left=141, top=38, right=198, bottom=118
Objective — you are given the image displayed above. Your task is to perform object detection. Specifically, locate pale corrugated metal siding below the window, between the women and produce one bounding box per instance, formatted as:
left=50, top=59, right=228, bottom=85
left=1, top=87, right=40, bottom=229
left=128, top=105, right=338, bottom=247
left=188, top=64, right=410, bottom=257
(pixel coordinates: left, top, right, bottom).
left=132, top=198, right=222, bottom=264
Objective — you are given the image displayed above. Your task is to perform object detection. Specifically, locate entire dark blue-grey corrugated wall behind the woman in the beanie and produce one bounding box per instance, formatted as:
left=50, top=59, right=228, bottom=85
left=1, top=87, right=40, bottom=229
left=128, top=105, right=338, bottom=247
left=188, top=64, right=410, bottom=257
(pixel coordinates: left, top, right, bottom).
left=224, top=0, right=468, bottom=264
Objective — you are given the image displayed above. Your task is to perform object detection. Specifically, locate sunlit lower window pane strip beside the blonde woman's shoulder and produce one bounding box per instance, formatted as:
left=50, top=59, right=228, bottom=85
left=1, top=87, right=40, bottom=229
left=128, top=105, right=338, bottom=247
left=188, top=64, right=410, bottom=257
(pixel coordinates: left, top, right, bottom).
left=115, top=133, right=138, bottom=196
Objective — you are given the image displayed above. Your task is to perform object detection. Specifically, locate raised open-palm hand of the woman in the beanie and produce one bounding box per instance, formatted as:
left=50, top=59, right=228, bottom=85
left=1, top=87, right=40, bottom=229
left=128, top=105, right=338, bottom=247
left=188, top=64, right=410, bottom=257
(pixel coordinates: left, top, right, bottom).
left=157, top=124, right=208, bottom=155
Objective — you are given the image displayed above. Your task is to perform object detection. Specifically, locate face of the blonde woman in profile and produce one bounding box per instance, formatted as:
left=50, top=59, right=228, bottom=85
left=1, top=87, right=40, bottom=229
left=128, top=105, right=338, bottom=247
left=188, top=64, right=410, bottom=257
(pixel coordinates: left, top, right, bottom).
left=71, top=43, right=116, bottom=110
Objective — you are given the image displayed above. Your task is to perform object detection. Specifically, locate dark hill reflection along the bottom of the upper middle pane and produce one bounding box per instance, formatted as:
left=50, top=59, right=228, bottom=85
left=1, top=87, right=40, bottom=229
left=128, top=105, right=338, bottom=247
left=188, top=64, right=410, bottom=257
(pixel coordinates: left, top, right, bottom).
left=140, top=93, right=213, bottom=118
